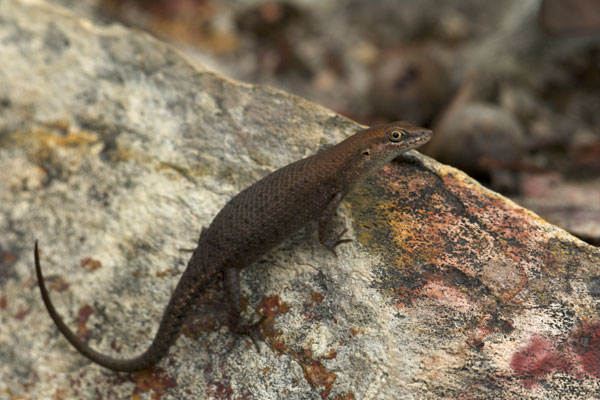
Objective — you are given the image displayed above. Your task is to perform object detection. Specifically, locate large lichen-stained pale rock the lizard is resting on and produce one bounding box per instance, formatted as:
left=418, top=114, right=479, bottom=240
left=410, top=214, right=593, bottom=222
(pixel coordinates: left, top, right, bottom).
left=0, top=0, right=600, bottom=399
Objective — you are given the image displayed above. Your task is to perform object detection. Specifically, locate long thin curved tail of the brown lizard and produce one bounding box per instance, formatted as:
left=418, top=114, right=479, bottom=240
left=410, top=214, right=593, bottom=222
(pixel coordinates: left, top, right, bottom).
left=34, top=240, right=204, bottom=372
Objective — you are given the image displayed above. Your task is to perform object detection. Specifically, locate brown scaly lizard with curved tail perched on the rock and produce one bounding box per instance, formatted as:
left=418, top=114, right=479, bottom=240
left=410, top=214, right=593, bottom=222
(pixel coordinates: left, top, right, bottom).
left=34, top=121, right=432, bottom=372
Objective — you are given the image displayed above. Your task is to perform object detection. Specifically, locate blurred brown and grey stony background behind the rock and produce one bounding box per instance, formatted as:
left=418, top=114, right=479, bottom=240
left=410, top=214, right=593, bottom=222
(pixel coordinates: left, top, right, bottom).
left=48, top=0, right=600, bottom=245
